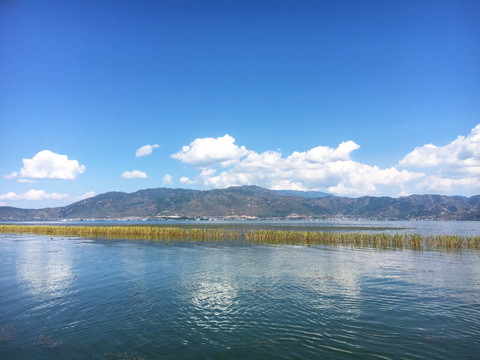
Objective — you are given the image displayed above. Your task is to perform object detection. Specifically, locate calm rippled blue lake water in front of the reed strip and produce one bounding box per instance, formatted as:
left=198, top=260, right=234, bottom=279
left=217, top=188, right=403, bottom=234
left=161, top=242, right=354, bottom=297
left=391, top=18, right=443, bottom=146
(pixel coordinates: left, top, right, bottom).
left=0, top=226, right=480, bottom=359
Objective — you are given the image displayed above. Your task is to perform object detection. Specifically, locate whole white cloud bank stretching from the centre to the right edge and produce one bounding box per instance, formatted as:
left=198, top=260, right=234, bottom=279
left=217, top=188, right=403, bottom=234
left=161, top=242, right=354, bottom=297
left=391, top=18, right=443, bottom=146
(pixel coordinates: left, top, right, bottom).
left=172, top=125, right=480, bottom=196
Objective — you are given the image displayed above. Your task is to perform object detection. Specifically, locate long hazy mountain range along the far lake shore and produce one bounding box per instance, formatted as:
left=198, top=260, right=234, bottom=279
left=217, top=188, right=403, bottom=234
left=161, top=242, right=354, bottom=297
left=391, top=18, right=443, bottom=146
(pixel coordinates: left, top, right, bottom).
left=0, top=186, right=480, bottom=221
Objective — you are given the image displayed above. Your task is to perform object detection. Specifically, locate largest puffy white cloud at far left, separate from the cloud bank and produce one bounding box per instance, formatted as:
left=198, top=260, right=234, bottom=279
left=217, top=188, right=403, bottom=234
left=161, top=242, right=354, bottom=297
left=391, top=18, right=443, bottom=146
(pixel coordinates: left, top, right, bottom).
left=20, top=150, right=85, bottom=180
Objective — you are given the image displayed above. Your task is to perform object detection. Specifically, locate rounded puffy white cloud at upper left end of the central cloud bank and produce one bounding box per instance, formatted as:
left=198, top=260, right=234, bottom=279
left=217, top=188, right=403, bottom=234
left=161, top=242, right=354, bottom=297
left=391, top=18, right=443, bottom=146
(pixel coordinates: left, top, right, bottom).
left=172, top=134, right=248, bottom=167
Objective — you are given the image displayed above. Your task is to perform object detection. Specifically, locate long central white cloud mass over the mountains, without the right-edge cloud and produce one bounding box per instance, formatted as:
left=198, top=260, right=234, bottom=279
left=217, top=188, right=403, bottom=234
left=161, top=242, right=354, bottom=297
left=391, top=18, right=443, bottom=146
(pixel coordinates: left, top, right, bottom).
left=172, top=135, right=424, bottom=195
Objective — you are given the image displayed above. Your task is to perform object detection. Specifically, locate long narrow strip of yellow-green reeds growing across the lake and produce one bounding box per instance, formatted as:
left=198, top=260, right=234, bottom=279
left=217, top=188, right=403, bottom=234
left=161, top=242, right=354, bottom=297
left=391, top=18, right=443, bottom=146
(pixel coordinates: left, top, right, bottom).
left=0, top=225, right=480, bottom=250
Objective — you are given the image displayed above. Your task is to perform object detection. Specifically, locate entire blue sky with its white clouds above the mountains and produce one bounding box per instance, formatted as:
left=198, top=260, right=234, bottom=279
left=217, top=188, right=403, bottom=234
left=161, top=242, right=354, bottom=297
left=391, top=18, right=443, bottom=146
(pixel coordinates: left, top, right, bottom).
left=0, top=0, right=480, bottom=208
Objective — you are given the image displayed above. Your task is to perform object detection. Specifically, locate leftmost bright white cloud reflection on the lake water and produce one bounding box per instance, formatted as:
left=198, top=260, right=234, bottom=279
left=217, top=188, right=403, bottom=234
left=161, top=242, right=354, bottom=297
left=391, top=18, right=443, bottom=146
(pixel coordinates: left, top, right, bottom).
left=16, top=240, right=73, bottom=300
